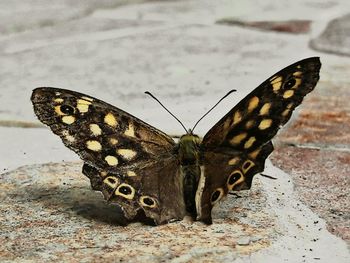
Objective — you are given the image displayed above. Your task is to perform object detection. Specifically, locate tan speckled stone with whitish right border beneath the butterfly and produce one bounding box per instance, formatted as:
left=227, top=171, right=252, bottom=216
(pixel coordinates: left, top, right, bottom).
left=0, top=162, right=348, bottom=262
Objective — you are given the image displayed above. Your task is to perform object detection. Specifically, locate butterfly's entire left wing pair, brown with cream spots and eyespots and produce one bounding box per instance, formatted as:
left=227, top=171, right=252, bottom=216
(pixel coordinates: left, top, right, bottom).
left=32, top=88, right=186, bottom=224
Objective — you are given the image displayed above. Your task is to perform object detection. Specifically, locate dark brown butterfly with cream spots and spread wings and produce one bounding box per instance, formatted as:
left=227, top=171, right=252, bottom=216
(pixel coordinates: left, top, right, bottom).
left=31, top=57, right=321, bottom=224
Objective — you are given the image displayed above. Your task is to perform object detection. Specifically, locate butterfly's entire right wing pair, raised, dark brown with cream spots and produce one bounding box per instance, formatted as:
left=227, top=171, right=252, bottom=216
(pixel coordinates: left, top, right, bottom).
left=197, top=57, right=321, bottom=222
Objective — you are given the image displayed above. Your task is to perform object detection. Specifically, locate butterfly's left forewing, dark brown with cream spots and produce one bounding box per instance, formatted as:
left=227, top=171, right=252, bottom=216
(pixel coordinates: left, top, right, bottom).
left=31, top=88, right=175, bottom=171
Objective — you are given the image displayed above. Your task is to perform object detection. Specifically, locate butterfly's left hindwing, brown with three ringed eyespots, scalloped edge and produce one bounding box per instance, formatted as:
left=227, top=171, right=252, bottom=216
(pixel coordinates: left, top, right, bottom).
left=83, top=157, right=186, bottom=224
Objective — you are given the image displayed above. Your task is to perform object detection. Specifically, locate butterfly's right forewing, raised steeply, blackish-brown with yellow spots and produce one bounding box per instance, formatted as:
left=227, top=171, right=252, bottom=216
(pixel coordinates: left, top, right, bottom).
left=202, top=57, right=321, bottom=152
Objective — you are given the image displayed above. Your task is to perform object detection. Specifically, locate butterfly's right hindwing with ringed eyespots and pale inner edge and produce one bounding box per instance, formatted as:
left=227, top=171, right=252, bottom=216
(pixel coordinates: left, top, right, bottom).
left=196, top=142, right=273, bottom=224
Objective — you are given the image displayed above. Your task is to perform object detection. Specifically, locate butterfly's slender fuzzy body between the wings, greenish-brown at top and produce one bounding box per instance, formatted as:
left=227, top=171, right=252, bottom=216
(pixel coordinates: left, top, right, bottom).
left=178, top=133, right=200, bottom=217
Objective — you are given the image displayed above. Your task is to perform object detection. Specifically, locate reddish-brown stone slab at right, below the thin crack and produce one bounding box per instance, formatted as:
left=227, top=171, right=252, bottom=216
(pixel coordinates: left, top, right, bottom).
left=272, top=145, right=350, bottom=244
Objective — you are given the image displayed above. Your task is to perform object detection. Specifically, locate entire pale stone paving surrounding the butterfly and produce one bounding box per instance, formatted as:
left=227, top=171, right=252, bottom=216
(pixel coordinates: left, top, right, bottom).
left=0, top=0, right=350, bottom=262
